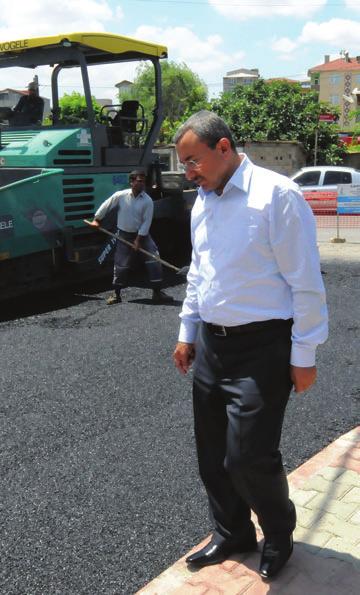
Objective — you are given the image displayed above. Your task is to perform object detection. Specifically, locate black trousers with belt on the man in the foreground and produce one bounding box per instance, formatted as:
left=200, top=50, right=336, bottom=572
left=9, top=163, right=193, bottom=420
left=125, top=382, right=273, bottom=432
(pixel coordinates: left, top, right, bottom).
left=193, top=320, right=296, bottom=540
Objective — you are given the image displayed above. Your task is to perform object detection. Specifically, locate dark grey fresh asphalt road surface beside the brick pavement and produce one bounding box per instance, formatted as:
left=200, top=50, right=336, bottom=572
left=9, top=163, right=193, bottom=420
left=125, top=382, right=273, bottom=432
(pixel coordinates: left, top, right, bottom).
left=0, top=245, right=360, bottom=595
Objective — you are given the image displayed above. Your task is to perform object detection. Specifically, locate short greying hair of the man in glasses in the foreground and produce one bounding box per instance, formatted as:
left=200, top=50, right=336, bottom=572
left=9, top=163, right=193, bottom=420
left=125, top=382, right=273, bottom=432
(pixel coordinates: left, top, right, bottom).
left=173, top=110, right=236, bottom=152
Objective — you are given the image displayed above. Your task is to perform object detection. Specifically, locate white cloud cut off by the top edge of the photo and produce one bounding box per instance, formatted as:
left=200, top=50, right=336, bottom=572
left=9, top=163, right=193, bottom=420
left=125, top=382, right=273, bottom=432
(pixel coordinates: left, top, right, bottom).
left=209, top=0, right=327, bottom=21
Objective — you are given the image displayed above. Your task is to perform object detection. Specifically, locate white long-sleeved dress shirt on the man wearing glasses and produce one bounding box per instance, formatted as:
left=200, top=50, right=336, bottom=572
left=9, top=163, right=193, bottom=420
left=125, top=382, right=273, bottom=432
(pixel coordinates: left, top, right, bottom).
left=179, top=154, right=327, bottom=367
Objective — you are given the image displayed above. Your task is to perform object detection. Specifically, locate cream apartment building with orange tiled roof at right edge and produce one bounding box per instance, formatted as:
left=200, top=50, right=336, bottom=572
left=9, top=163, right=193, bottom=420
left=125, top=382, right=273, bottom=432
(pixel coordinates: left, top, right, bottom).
left=308, top=52, right=360, bottom=131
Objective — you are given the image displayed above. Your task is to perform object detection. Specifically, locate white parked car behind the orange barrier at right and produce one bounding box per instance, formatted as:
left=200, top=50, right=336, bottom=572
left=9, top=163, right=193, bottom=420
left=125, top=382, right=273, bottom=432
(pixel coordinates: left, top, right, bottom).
left=291, top=165, right=360, bottom=215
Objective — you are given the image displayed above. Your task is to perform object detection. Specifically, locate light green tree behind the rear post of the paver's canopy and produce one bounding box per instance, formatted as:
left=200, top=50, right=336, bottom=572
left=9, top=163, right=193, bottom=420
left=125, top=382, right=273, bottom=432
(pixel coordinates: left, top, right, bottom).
left=120, top=60, right=208, bottom=142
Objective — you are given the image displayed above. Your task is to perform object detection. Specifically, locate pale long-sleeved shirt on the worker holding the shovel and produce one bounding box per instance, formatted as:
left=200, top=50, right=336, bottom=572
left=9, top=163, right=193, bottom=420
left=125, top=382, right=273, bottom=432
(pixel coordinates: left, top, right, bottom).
left=94, top=188, right=154, bottom=236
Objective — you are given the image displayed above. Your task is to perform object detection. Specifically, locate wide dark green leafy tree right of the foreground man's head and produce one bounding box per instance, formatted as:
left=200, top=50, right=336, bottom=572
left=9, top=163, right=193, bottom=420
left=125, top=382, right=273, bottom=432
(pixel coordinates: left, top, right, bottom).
left=211, top=79, right=344, bottom=164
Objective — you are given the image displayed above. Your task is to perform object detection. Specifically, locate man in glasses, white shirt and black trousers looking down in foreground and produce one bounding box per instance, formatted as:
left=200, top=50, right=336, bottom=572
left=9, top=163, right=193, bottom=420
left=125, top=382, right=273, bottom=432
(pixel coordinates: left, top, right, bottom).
left=173, top=110, right=327, bottom=579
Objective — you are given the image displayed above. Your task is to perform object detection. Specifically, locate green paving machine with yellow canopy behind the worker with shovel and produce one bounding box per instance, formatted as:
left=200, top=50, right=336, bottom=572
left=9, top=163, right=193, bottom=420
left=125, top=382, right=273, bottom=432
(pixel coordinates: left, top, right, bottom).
left=0, top=33, right=189, bottom=299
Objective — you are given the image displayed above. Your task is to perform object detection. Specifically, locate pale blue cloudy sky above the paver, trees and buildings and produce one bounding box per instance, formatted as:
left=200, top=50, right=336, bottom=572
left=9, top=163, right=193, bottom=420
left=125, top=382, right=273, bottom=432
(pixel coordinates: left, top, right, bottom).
left=0, top=0, right=360, bottom=98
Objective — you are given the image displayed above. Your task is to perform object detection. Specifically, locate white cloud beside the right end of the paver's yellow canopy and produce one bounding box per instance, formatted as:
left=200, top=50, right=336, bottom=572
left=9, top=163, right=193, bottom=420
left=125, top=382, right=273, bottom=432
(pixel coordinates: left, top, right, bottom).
left=134, top=25, right=245, bottom=82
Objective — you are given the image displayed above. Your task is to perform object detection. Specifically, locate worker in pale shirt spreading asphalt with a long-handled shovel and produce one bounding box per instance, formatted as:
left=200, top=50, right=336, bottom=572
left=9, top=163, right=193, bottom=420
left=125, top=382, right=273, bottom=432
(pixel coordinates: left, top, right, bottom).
left=92, top=170, right=173, bottom=305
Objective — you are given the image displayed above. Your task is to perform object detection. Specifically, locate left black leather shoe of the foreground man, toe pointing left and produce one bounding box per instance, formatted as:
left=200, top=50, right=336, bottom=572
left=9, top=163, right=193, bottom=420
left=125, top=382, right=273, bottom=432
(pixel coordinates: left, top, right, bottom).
left=186, top=530, right=257, bottom=568
